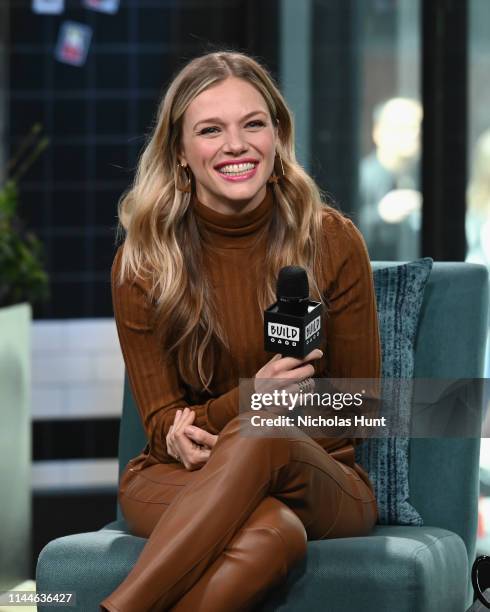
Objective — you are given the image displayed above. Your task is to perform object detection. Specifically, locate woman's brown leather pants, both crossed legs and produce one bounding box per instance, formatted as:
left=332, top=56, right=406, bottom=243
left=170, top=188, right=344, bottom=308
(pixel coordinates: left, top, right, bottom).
left=101, top=414, right=377, bottom=612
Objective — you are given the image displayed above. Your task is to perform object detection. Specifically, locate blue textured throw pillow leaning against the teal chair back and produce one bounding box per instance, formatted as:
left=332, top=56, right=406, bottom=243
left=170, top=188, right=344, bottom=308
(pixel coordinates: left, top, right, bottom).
left=356, top=257, right=433, bottom=525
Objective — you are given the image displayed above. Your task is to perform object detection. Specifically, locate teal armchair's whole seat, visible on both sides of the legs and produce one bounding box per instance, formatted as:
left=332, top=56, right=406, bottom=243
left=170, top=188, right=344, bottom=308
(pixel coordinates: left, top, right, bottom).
left=36, top=521, right=468, bottom=612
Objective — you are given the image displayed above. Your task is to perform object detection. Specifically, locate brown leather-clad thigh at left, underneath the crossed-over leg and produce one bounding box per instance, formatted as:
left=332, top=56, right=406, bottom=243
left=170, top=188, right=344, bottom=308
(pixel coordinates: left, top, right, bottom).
left=119, top=462, right=198, bottom=538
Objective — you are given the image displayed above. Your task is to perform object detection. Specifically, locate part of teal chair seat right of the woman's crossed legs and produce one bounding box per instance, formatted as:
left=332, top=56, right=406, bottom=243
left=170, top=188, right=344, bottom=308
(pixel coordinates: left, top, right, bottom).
left=261, top=525, right=468, bottom=612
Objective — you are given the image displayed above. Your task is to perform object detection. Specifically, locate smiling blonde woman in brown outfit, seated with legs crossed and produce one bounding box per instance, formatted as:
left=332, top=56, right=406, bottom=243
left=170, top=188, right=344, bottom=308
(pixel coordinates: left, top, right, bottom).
left=101, top=52, right=380, bottom=612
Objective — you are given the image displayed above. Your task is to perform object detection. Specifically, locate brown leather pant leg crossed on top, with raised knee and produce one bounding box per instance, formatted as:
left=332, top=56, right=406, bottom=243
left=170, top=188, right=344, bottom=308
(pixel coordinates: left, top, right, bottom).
left=102, top=413, right=376, bottom=612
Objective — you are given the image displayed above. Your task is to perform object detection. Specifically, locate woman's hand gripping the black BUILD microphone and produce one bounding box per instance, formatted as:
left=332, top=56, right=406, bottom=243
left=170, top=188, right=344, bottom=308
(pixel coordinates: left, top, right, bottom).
left=254, top=349, right=323, bottom=393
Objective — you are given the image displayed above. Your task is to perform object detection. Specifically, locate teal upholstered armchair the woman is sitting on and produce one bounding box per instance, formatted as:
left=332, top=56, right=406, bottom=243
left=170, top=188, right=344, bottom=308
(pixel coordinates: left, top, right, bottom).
left=36, top=262, right=488, bottom=612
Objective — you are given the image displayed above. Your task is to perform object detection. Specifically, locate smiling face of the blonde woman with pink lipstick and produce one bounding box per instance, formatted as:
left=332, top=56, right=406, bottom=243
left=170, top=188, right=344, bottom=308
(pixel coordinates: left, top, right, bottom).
left=179, top=77, right=277, bottom=214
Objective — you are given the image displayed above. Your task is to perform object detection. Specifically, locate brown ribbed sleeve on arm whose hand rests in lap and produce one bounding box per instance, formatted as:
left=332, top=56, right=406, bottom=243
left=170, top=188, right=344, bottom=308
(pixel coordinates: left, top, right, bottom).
left=111, top=248, right=239, bottom=462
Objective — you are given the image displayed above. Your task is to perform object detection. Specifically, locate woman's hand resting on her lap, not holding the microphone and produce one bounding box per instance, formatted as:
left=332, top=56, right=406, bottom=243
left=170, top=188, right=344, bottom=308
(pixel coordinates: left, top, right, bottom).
left=166, top=408, right=218, bottom=471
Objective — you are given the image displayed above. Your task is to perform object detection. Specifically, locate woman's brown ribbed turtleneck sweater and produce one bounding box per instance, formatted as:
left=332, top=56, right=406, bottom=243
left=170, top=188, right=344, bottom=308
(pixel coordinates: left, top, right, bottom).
left=112, top=188, right=380, bottom=465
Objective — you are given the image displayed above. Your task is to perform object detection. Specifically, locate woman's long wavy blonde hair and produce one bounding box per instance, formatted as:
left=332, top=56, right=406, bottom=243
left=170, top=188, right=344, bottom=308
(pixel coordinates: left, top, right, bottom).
left=118, top=51, right=334, bottom=393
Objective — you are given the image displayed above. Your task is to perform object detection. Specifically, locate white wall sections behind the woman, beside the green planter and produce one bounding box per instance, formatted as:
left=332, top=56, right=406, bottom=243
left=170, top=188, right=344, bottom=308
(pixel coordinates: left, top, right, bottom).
left=31, top=319, right=124, bottom=491
